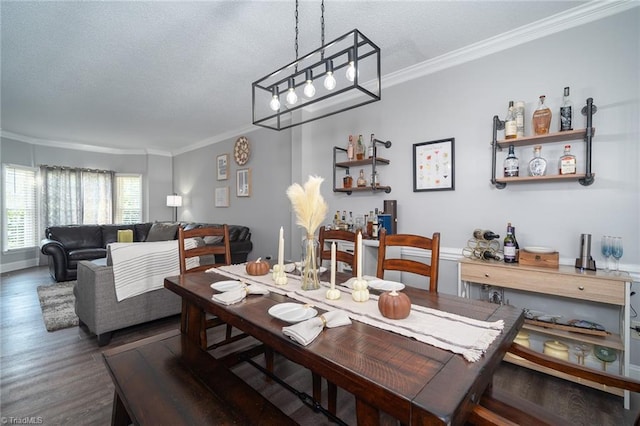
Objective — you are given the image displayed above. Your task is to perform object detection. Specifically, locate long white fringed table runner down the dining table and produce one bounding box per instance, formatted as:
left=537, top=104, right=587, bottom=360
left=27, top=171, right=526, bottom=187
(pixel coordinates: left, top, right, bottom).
left=212, top=264, right=504, bottom=362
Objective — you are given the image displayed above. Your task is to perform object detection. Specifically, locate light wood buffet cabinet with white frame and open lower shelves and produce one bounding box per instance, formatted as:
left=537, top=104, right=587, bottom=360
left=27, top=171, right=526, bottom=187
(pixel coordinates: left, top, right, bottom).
left=458, top=259, right=631, bottom=408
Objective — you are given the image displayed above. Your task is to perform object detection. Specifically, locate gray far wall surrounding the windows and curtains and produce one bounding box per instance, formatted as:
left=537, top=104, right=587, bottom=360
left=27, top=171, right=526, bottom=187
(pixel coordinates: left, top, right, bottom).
left=0, top=138, right=173, bottom=272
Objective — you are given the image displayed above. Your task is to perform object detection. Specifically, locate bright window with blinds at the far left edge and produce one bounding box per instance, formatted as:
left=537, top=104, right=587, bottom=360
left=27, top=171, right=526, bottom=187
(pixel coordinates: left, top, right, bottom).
left=2, top=164, right=38, bottom=251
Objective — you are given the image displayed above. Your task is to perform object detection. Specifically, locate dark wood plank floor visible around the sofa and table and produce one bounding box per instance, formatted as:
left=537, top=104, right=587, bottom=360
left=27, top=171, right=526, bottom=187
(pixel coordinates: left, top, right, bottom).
left=0, top=267, right=640, bottom=426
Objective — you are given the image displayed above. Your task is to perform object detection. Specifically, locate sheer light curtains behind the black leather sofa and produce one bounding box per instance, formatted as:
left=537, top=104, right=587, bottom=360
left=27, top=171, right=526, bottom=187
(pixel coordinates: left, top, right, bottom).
left=40, top=166, right=113, bottom=229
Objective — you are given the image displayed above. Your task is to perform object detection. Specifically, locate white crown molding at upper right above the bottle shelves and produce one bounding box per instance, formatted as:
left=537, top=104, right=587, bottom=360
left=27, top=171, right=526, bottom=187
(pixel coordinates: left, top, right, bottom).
left=382, top=0, right=640, bottom=87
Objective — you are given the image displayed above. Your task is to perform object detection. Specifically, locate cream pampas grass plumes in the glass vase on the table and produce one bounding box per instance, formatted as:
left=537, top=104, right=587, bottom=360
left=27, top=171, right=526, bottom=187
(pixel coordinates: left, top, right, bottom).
left=287, top=176, right=329, bottom=236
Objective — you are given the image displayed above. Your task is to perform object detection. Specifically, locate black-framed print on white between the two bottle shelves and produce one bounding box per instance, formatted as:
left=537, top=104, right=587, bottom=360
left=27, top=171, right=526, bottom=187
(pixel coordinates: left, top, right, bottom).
left=413, top=138, right=455, bottom=192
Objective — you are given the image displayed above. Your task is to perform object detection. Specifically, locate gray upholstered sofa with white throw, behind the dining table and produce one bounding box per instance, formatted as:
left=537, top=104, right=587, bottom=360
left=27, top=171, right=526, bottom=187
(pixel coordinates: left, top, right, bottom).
left=73, top=258, right=182, bottom=346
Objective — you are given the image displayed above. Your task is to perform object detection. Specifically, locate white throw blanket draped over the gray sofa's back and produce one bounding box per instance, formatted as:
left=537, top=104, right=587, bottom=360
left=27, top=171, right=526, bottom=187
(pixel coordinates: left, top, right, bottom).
left=109, top=238, right=200, bottom=302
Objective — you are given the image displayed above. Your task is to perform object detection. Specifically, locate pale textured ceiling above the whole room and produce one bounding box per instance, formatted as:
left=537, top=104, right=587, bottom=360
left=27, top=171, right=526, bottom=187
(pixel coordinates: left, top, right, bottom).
left=0, top=0, right=585, bottom=152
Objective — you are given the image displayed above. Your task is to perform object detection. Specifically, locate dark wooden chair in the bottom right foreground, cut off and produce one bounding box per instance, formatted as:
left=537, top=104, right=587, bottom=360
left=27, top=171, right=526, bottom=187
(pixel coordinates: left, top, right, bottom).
left=468, top=343, right=640, bottom=426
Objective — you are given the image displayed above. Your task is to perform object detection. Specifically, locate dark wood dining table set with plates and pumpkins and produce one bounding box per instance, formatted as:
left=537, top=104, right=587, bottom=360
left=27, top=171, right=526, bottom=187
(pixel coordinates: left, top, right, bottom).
left=164, top=272, right=523, bottom=425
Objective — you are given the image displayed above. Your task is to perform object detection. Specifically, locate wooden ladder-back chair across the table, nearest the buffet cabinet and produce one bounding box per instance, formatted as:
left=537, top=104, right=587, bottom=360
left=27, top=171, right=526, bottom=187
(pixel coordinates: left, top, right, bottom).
left=376, top=229, right=440, bottom=293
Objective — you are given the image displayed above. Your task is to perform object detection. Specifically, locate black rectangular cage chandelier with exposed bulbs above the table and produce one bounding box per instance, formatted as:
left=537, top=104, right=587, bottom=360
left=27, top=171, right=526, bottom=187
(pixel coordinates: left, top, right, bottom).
left=252, top=29, right=381, bottom=130
